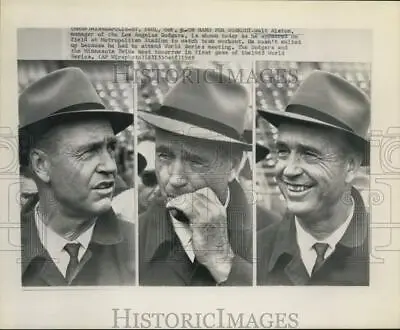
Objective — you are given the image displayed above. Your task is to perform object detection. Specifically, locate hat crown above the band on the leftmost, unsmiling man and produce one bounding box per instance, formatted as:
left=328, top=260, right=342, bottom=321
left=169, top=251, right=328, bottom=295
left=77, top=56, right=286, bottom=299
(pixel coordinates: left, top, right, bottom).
left=18, top=67, right=104, bottom=127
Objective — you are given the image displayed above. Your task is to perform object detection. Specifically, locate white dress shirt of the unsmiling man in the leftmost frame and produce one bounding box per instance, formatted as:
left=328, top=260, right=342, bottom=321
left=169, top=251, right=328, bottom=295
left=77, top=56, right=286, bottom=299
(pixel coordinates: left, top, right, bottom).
left=35, top=203, right=95, bottom=277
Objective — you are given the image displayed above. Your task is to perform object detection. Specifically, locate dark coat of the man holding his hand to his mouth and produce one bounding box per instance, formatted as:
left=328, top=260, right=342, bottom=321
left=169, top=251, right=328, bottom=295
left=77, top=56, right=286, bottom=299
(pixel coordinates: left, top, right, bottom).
left=139, top=181, right=253, bottom=286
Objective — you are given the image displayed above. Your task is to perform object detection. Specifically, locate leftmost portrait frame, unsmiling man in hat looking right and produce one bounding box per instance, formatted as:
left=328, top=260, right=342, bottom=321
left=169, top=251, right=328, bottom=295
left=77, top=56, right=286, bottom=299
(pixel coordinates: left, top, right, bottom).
left=18, top=60, right=137, bottom=287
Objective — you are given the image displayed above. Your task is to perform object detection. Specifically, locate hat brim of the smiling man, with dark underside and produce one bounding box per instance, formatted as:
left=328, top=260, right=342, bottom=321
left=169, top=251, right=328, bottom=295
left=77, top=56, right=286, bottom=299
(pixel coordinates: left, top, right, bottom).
left=257, top=109, right=370, bottom=166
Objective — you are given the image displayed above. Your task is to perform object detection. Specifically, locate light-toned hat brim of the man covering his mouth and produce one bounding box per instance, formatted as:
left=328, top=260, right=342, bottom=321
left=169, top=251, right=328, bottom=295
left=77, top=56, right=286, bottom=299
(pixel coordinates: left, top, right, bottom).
left=138, top=110, right=252, bottom=151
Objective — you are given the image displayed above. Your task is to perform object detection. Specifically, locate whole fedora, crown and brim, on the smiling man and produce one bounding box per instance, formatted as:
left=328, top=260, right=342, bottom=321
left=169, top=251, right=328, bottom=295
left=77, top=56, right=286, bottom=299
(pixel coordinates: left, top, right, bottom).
left=258, top=70, right=371, bottom=165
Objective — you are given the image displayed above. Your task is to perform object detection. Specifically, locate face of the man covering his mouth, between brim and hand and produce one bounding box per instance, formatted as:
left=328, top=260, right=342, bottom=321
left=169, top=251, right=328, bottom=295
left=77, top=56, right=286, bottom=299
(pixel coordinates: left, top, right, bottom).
left=155, top=129, right=234, bottom=203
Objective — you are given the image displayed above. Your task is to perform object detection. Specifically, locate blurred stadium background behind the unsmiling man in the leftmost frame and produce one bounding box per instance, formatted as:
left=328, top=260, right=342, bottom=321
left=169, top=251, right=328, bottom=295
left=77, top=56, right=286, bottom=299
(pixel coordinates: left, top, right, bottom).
left=18, top=60, right=135, bottom=206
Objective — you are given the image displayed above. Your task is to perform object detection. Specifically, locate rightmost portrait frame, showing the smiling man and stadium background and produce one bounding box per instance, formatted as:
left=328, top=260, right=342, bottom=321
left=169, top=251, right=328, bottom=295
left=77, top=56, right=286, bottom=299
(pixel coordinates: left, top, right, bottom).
left=256, top=61, right=371, bottom=286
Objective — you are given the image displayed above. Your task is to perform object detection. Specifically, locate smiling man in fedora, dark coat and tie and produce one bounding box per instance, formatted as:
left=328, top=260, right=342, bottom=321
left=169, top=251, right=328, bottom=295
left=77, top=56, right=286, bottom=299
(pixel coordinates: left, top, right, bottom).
left=257, top=71, right=370, bottom=285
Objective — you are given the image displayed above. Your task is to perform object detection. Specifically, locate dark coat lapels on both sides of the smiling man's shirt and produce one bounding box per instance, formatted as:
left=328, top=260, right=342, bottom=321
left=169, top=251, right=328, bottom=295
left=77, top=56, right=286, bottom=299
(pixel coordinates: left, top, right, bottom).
left=268, top=187, right=369, bottom=270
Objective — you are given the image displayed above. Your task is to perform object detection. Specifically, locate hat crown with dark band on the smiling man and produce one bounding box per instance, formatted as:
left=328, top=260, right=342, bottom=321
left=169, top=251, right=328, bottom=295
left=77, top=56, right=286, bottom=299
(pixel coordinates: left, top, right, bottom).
left=286, top=70, right=371, bottom=138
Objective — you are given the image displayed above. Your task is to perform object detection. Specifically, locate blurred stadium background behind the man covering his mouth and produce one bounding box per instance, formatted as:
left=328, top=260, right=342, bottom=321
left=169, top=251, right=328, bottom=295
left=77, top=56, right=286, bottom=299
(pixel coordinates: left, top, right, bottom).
left=135, top=61, right=254, bottom=213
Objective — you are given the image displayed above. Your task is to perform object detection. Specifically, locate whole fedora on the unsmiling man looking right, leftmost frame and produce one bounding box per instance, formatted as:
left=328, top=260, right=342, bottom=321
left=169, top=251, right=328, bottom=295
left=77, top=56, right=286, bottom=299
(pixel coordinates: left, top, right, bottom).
left=18, top=67, right=133, bottom=163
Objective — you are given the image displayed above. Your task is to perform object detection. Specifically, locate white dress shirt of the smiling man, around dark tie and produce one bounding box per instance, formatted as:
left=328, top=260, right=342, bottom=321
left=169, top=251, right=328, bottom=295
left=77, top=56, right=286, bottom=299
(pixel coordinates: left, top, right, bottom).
left=295, top=198, right=354, bottom=276
